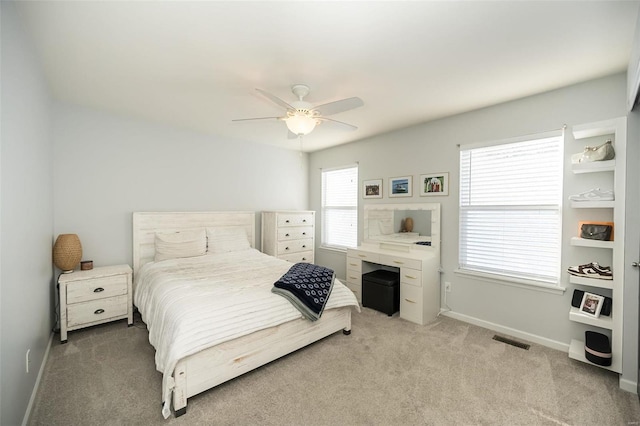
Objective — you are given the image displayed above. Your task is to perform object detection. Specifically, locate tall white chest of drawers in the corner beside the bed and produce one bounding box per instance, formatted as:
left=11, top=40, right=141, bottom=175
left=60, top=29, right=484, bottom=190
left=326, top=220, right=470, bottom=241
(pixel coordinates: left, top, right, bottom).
left=262, top=210, right=315, bottom=263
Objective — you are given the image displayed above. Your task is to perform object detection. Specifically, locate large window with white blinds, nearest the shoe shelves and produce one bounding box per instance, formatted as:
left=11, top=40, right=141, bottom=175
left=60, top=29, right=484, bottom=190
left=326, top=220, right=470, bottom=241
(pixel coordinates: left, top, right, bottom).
left=459, top=131, right=563, bottom=286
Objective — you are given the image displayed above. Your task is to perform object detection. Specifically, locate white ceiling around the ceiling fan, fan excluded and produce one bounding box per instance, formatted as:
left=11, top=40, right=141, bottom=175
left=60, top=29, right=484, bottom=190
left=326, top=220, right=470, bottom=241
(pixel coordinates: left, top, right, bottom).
left=18, top=1, right=639, bottom=151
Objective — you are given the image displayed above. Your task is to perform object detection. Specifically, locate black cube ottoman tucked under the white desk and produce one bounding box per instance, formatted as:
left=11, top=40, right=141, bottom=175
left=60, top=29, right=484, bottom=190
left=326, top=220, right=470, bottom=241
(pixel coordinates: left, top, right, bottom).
left=362, top=269, right=400, bottom=316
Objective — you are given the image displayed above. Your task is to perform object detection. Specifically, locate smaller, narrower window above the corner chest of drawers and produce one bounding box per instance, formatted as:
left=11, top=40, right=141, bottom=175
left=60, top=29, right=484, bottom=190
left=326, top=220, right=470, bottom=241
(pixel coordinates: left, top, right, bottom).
left=322, top=166, right=358, bottom=249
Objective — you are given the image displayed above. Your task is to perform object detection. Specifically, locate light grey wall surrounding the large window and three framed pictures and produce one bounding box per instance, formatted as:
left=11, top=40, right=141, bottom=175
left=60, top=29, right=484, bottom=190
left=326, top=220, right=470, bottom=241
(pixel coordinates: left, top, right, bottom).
left=309, top=74, right=638, bottom=390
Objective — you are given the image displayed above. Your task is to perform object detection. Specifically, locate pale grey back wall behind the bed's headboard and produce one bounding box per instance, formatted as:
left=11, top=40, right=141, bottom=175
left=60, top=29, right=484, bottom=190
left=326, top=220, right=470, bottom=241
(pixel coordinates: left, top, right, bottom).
left=53, top=104, right=308, bottom=266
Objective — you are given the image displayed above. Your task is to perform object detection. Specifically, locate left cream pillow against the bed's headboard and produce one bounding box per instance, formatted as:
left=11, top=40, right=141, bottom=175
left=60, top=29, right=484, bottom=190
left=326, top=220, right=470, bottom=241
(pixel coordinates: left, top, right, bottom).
left=155, top=228, right=207, bottom=262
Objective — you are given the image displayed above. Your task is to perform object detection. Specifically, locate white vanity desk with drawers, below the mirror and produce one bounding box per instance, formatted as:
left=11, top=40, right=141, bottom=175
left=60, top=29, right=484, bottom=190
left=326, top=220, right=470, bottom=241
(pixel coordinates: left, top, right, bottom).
left=347, top=244, right=440, bottom=325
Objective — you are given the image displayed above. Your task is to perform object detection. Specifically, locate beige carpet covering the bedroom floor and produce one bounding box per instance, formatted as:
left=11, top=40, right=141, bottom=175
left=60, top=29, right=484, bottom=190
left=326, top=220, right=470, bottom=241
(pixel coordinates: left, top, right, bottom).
left=29, top=309, right=640, bottom=425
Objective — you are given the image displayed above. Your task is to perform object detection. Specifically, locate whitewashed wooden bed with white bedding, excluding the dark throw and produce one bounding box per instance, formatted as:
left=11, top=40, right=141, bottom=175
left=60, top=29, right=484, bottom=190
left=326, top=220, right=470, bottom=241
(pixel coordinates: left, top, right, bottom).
left=133, top=212, right=359, bottom=418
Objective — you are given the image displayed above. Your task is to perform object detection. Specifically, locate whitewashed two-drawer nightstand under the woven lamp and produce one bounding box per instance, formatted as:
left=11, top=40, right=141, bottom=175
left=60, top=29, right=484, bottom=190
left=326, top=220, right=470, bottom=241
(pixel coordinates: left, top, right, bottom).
left=58, top=265, right=133, bottom=343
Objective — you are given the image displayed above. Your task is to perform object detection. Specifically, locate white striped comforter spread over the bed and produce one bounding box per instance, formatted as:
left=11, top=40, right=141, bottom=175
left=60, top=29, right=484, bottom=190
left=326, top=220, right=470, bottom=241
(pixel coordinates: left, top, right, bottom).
left=134, top=249, right=359, bottom=418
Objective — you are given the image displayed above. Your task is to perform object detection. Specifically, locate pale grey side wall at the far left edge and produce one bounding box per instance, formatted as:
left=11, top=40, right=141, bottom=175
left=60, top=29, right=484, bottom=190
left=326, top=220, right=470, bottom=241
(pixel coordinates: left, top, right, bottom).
left=0, top=1, right=54, bottom=425
